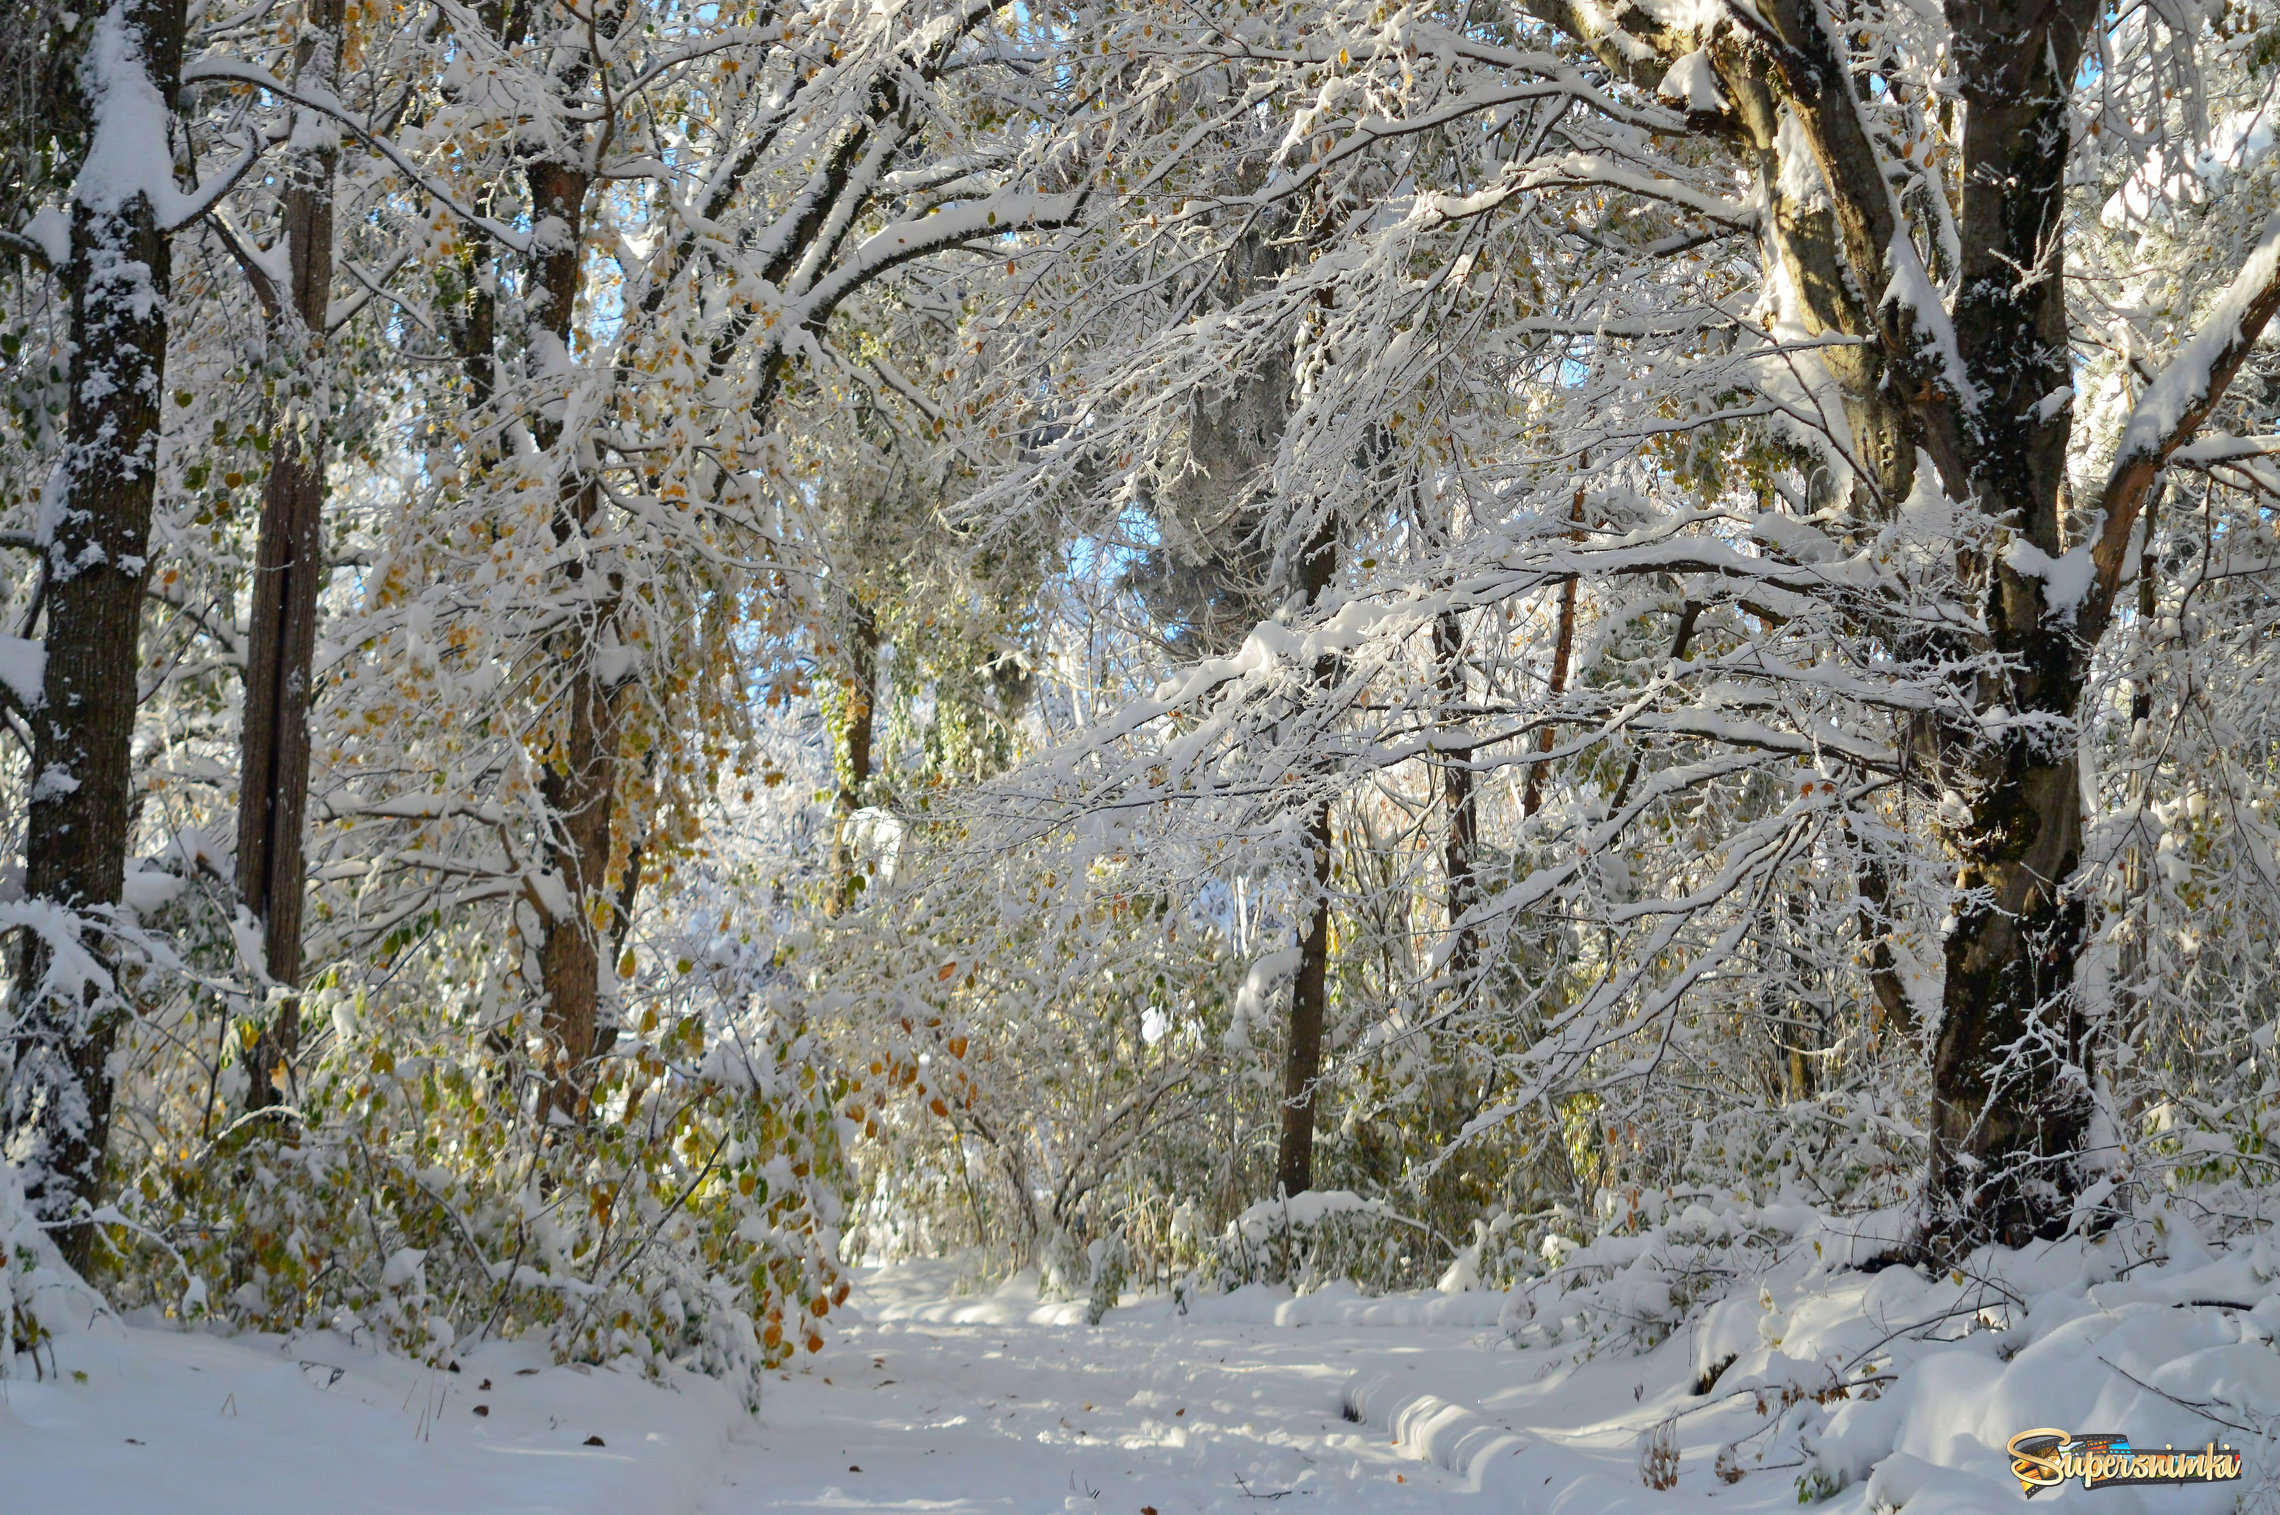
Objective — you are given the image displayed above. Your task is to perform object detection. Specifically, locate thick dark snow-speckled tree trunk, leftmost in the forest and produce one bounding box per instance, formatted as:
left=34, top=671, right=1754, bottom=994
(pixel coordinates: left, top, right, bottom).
left=7, top=0, right=182, bottom=1264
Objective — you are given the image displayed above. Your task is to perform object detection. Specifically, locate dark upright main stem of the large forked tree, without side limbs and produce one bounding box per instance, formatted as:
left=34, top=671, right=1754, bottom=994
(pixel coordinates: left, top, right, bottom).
left=1927, top=0, right=2095, bottom=1255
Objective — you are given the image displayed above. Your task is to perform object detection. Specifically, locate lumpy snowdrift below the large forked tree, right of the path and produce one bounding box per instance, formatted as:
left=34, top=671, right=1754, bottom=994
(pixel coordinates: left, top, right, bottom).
left=1343, top=1207, right=2280, bottom=1515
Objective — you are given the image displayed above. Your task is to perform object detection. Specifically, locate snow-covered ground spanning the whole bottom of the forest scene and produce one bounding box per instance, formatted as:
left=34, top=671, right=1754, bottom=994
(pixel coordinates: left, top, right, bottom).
left=13, top=1243, right=2280, bottom=1515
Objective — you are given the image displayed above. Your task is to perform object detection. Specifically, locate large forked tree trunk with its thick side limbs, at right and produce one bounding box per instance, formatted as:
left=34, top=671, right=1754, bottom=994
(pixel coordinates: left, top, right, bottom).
left=1530, top=0, right=2124, bottom=1257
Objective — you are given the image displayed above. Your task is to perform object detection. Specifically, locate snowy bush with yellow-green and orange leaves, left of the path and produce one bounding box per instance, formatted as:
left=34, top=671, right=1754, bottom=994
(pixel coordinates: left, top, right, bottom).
left=84, top=880, right=848, bottom=1394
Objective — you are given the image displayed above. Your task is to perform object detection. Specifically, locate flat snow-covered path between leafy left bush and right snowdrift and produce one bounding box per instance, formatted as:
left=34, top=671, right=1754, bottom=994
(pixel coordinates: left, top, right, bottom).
left=702, top=1287, right=1513, bottom=1515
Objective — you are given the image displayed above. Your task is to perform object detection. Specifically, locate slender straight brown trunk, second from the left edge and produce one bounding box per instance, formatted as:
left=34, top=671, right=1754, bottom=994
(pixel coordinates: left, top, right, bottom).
left=237, top=0, right=342, bottom=1109
